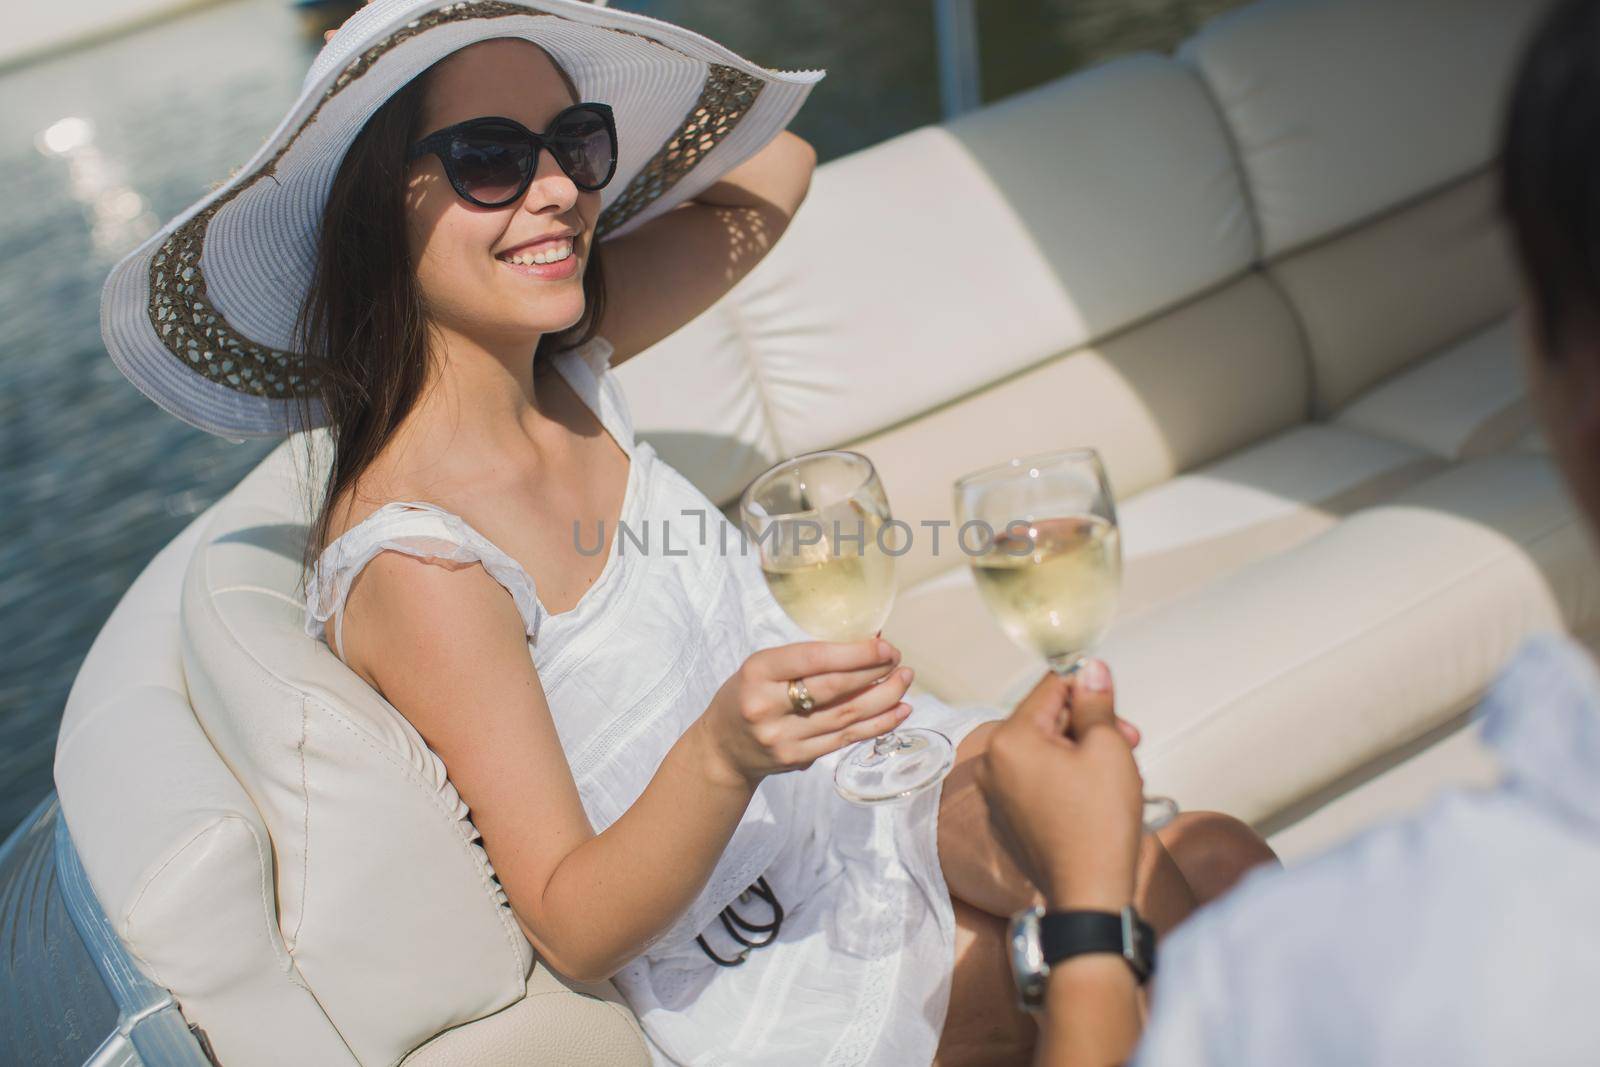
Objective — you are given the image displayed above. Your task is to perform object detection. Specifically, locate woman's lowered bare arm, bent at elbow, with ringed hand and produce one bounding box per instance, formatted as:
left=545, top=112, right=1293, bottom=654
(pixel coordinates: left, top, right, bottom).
left=344, top=552, right=910, bottom=981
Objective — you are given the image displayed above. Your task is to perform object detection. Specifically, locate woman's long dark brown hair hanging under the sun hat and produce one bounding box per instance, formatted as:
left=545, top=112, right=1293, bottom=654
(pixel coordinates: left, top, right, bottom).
left=294, top=48, right=605, bottom=574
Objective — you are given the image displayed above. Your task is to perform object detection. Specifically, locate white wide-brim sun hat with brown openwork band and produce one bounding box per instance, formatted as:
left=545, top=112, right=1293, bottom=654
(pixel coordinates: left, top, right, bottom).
left=101, top=0, right=824, bottom=442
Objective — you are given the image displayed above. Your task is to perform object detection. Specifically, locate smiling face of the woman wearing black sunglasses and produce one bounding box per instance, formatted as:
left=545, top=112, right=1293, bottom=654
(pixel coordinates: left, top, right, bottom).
left=406, top=38, right=600, bottom=355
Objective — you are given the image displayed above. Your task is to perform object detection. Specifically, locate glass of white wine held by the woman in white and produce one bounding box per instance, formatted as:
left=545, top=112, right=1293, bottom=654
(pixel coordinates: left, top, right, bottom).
left=739, top=450, right=955, bottom=805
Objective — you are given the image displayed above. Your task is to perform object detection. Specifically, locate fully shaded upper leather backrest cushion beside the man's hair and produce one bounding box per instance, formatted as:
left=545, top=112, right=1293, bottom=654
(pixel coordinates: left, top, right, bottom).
left=1179, top=0, right=1547, bottom=258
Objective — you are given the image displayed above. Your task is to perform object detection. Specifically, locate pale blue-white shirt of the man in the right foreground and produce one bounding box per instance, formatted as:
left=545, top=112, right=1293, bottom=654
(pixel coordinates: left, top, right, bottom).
left=1133, top=635, right=1600, bottom=1067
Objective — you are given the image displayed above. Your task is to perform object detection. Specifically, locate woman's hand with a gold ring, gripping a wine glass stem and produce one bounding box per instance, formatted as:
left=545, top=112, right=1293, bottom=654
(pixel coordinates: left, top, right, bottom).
left=699, top=638, right=912, bottom=787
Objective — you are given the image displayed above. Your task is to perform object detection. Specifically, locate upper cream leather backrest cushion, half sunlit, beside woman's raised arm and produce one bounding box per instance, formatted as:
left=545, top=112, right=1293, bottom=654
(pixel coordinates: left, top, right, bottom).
left=619, top=56, right=1256, bottom=502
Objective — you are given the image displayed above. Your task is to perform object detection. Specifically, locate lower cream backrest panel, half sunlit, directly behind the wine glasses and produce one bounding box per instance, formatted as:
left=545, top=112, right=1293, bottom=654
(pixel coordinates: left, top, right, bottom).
left=850, top=272, right=1309, bottom=587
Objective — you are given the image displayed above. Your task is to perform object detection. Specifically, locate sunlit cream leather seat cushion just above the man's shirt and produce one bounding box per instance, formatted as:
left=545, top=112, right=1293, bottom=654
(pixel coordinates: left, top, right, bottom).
left=1104, top=454, right=1600, bottom=819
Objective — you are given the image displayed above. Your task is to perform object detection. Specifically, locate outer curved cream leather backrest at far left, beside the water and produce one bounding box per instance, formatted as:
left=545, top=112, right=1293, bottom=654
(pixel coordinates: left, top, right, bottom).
left=54, top=506, right=355, bottom=1067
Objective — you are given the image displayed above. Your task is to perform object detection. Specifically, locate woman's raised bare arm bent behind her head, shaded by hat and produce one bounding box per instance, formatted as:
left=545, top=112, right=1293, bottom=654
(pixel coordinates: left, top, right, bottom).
left=600, top=130, right=816, bottom=365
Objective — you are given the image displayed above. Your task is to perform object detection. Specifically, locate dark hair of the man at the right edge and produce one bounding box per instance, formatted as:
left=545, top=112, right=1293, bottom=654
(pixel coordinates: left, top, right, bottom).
left=1501, top=0, right=1600, bottom=362
